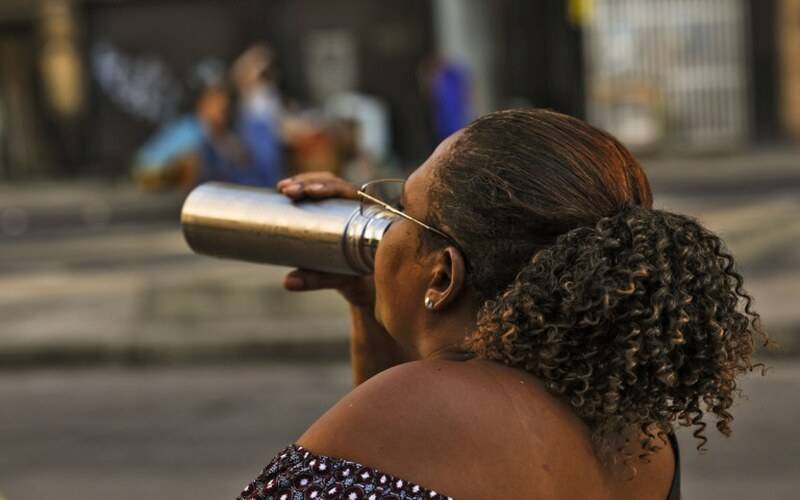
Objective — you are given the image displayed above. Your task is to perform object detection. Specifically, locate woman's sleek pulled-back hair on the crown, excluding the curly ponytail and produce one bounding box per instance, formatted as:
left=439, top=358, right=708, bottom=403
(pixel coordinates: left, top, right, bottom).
left=425, top=109, right=653, bottom=300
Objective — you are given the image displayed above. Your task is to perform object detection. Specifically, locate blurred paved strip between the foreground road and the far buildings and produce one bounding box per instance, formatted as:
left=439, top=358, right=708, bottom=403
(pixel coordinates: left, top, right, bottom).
left=0, top=151, right=800, bottom=367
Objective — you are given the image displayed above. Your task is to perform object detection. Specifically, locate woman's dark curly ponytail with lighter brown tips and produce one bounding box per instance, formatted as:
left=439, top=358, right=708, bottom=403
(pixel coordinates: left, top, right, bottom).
left=467, top=207, right=768, bottom=458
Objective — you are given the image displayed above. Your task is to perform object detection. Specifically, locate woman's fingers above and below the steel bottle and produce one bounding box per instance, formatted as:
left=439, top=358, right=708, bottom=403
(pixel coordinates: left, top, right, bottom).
left=278, top=172, right=375, bottom=311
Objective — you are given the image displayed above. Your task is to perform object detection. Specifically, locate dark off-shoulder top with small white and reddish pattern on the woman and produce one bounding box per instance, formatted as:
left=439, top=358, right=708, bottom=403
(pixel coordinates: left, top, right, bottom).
left=237, top=444, right=453, bottom=500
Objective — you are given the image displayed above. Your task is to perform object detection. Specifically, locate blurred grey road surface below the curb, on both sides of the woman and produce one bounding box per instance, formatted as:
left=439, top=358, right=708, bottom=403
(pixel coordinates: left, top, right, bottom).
left=0, top=360, right=800, bottom=500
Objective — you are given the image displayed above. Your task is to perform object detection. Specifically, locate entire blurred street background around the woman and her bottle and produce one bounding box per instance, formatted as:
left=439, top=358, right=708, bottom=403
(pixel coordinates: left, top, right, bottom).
left=0, top=0, right=800, bottom=500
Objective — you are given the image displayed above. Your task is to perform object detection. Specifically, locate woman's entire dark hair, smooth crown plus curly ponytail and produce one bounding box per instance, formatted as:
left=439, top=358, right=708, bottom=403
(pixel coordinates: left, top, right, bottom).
left=423, top=110, right=768, bottom=463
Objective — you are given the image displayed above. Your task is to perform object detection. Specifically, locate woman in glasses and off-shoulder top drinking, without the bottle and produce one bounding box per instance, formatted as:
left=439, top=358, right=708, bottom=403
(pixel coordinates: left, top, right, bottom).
left=234, top=110, right=766, bottom=500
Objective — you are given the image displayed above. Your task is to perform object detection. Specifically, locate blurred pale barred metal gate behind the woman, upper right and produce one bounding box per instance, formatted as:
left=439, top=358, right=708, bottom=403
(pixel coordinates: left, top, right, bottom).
left=584, top=0, right=750, bottom=152
